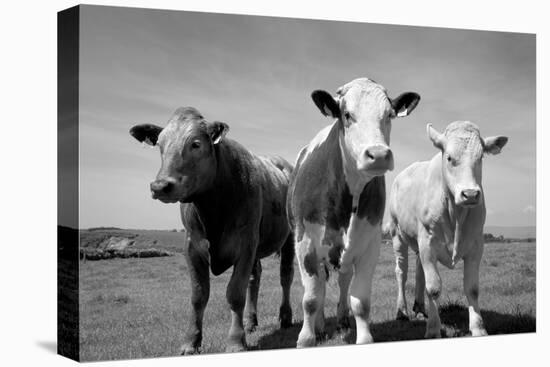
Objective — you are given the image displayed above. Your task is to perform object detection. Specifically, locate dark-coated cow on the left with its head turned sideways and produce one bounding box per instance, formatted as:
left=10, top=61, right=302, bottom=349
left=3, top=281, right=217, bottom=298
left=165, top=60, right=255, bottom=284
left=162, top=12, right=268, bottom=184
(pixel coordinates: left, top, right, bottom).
left=130, top=107, right=294, bottom=354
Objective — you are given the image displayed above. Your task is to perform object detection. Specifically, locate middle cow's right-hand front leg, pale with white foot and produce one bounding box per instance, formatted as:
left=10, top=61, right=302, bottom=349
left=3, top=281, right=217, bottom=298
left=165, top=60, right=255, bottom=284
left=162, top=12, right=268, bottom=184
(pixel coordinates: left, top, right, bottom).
left=350, top=230, right=382, bottom=344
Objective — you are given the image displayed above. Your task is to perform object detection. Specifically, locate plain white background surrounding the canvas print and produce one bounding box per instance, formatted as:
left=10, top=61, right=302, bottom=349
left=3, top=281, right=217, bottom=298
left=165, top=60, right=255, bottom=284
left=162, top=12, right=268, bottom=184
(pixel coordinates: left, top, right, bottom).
left=0, top=0, right=550, bottom=367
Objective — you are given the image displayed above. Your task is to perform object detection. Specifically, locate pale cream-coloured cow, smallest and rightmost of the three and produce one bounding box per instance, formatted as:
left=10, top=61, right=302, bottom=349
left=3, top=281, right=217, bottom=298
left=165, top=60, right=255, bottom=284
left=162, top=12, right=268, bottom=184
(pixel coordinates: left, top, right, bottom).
left=388, top=121, right=508, bottom=338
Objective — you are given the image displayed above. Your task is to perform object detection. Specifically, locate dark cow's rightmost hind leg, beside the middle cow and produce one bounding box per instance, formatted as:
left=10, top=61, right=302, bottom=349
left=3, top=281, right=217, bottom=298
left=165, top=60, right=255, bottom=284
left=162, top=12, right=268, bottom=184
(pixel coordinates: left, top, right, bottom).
left=279, top=233, right=295, bottom=328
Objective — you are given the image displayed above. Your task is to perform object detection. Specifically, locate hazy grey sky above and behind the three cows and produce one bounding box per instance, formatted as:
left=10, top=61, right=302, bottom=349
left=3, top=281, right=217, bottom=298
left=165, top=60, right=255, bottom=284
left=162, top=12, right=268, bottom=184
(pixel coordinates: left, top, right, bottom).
left=72, top=6, right=536, bottom=229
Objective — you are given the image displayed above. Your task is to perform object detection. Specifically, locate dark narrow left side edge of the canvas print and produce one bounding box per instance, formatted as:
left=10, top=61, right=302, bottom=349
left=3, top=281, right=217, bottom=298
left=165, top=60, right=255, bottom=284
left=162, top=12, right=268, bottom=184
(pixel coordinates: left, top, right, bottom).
left=57, top=6, right=80, bottom=361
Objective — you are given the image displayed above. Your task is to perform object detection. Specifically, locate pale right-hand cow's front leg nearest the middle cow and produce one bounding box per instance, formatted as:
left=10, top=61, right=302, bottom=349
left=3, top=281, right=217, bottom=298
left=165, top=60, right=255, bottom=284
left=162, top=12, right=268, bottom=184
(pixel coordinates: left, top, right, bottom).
left=419, top=239, right=441, bottom=338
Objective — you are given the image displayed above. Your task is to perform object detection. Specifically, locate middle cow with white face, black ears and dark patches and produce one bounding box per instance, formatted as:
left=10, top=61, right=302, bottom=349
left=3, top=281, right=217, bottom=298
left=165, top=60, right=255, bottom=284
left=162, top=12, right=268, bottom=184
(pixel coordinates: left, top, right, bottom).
left=287, top=78, right=420, bottom=347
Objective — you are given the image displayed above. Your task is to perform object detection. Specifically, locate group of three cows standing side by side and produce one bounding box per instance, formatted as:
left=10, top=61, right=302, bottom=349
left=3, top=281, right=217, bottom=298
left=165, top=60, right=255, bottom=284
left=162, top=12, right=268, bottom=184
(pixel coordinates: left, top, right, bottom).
left=130, top=78, right=508, bottom=354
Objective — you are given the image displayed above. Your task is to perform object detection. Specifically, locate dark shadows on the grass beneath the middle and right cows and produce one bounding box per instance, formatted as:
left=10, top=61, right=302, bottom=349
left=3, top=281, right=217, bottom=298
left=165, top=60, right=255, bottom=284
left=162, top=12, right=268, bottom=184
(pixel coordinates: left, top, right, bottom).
left=252, top=303, right=536, bottom=350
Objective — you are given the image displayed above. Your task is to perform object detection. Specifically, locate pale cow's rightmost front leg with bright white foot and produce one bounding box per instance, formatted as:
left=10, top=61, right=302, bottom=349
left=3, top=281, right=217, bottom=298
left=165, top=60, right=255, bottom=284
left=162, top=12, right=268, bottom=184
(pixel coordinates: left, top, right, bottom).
left=464, top=242, right=487, bottom=336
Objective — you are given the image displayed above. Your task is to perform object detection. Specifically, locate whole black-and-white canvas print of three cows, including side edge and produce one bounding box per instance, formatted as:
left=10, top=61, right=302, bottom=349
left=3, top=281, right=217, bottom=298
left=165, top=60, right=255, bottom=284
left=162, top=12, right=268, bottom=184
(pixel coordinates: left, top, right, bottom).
left=57, top=5, right=538, bottom=363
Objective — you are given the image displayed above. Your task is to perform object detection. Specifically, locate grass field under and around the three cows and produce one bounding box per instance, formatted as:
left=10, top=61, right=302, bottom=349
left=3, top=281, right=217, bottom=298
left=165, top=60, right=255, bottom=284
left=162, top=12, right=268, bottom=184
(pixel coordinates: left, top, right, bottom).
left=80, top=231, right=536, bottom=361
